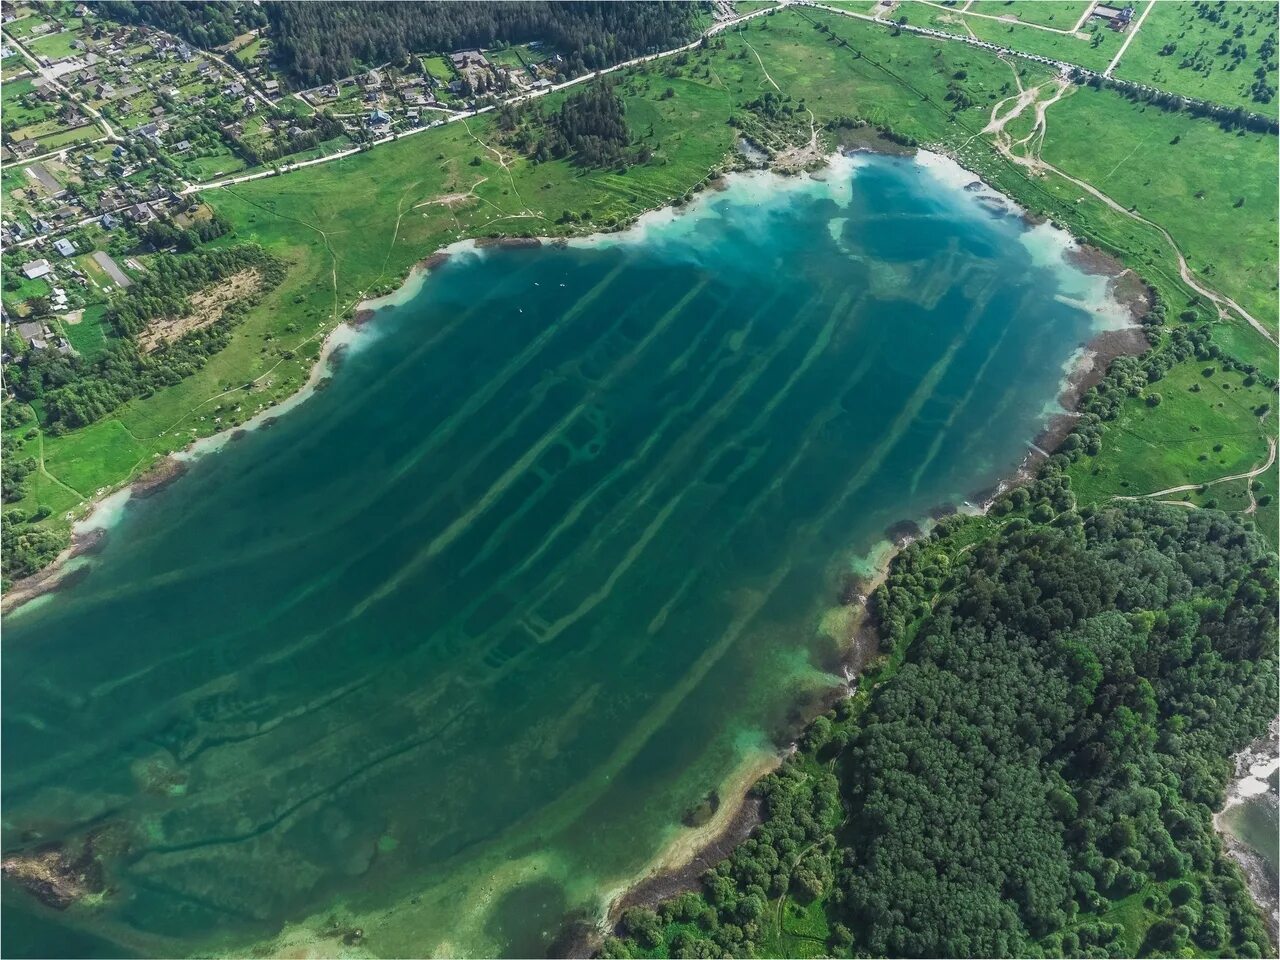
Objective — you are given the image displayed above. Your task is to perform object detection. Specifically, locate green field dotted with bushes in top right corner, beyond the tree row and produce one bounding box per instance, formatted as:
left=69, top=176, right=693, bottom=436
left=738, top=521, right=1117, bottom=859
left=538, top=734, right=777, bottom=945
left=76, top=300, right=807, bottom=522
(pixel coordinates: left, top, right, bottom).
left=1115, top=0, right=1280, bottom=116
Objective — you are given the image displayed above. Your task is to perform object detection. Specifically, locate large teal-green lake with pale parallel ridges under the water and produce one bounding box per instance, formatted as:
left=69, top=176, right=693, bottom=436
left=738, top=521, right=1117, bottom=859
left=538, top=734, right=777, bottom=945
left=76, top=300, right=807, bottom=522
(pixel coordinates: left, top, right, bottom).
left=3, top=157, right=1121, bottom=955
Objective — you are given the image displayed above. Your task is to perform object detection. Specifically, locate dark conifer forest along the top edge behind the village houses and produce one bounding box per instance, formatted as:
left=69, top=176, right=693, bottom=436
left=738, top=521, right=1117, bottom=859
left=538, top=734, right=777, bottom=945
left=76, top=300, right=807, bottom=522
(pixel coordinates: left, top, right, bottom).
left=265, top=0, right=698, bottom=87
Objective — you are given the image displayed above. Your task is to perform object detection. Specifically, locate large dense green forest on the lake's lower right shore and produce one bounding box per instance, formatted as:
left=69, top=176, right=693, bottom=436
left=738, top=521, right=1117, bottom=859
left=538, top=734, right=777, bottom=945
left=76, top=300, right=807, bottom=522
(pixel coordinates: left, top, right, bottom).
left=604, top=491, right=1277, bottom=956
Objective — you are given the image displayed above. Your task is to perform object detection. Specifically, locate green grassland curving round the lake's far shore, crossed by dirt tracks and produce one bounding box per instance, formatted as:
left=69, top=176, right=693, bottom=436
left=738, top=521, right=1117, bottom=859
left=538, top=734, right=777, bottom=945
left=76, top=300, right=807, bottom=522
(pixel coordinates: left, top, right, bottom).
left=24, top=8, right=1276, bottom=552
